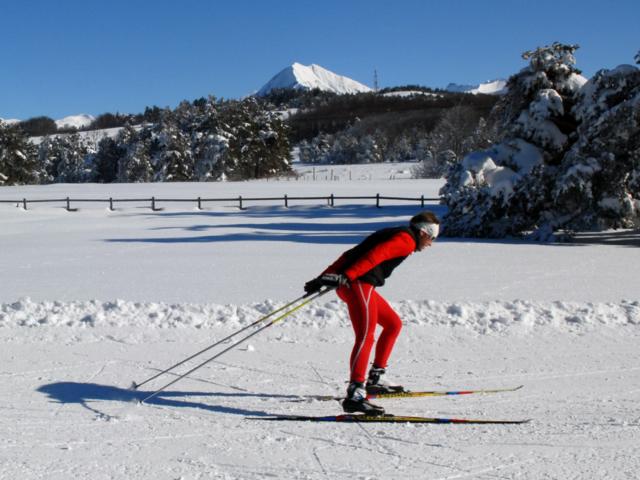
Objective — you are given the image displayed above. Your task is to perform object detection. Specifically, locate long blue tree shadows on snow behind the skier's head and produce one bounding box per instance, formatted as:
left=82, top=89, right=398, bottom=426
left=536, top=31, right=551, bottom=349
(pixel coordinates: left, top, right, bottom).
left=105, top=204, right=640, bottom=247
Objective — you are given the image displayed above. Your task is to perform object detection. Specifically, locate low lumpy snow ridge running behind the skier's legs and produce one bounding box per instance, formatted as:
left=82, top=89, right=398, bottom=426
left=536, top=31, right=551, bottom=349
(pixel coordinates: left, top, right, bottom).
left=0, top=298, right=640, bottom=334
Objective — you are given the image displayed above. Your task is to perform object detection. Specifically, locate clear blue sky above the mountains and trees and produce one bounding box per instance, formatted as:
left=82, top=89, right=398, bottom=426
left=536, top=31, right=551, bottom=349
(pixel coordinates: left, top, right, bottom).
left=0, top=0, right=640, bottom=119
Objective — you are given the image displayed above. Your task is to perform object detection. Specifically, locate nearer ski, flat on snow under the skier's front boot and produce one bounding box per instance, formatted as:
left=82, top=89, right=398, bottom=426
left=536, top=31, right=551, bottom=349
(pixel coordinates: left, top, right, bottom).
left=245, top=414, right=531, bottom=425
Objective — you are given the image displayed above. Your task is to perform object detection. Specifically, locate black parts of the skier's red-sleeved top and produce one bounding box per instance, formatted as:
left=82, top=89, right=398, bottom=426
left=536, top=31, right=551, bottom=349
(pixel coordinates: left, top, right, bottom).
left=342, top=227, right=419, bottom=287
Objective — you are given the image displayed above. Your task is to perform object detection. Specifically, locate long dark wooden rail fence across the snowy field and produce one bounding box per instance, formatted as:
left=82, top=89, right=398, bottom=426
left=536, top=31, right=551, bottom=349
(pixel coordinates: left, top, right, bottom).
left=0, top=193, right=440, bottom=212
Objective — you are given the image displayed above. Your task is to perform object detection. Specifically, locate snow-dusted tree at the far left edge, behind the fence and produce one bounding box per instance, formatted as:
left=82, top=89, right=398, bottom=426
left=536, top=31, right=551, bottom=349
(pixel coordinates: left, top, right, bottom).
left=0, top=120, right=43, bottom=185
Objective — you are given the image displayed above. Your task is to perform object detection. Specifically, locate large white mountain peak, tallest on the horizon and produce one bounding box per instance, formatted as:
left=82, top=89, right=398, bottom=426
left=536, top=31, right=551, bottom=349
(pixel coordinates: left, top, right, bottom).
left=258, top=62, right=371, bottom=96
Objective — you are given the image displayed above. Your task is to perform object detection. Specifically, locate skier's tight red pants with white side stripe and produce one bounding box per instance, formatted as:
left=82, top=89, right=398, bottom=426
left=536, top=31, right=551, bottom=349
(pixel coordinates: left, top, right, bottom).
left=336, top=281, right=402, bottom=382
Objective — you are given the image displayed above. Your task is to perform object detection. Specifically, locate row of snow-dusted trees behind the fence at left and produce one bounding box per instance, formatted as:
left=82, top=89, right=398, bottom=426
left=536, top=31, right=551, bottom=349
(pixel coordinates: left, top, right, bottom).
left=0, top=97, right=291, bottom=185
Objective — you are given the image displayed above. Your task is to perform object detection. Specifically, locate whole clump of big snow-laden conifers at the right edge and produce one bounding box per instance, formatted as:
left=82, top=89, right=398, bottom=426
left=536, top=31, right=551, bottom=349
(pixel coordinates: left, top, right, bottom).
left=441, top=43, right=640, bottom=239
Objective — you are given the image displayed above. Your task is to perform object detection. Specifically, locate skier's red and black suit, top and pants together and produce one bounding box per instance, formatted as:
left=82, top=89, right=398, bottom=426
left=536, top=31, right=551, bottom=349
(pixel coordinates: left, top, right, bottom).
left=323, top=228, right=417, bottom=382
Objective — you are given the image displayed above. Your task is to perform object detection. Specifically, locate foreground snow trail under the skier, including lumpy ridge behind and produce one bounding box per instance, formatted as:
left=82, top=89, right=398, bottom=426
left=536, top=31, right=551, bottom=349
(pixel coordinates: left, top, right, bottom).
left=0, top=300, right=640, bottom=479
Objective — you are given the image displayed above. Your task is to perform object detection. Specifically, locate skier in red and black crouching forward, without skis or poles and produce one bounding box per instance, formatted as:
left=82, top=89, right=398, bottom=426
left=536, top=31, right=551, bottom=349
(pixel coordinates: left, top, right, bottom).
left=304, top=211, right=440, bottom=415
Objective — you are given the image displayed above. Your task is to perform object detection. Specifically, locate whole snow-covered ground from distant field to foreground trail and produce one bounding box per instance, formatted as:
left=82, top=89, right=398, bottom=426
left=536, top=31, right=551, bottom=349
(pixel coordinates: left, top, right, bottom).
left=0, top=171, right=640, bottom=479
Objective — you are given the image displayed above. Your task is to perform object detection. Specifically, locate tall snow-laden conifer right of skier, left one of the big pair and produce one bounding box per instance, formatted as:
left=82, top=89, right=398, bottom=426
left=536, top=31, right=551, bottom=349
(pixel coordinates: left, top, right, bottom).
left=441, top=43, right=586, bottom=237
